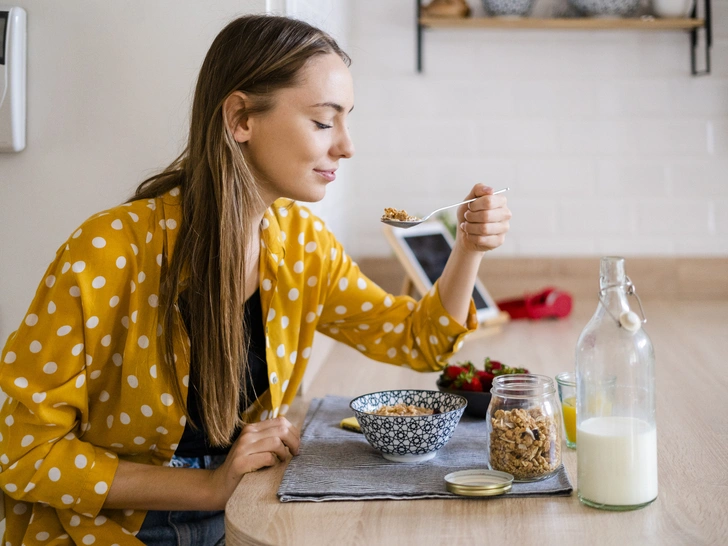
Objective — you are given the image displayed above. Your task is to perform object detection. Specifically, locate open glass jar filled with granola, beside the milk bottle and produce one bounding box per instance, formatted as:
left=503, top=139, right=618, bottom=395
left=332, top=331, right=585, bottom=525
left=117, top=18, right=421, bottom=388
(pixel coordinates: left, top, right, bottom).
left=486, top=374, right=561, bottom=482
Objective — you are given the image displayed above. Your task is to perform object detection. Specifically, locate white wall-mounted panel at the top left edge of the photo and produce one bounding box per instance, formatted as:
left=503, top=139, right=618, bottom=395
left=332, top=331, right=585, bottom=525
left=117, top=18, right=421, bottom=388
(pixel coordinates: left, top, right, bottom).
left=0, top=6, right=27, bottom=152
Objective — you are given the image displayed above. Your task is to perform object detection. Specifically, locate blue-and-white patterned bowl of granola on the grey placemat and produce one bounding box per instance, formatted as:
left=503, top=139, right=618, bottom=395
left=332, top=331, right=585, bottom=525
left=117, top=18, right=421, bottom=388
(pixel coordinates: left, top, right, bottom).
left=349, top=390, right=468, bottom=463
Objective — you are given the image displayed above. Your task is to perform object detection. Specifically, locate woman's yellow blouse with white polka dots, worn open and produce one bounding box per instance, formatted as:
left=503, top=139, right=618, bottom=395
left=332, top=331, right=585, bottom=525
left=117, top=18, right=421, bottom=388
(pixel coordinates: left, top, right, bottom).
left=0, top=189, right=476, bottom=546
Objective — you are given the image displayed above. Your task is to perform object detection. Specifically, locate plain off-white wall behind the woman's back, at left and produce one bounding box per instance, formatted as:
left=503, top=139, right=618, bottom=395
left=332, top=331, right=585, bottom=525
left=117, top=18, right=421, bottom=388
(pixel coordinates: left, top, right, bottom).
left=0, top=0, right=266, bottom=345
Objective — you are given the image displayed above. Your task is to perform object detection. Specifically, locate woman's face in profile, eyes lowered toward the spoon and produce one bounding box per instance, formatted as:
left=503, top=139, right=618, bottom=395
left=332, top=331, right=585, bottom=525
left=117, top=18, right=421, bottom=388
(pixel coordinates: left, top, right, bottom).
left=244, top=53, right=354, bottom=204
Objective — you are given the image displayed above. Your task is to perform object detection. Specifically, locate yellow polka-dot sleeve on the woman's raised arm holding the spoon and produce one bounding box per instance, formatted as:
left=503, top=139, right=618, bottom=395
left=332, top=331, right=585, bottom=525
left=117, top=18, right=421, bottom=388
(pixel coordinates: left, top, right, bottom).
left=318, top=227, right=477, bottom=371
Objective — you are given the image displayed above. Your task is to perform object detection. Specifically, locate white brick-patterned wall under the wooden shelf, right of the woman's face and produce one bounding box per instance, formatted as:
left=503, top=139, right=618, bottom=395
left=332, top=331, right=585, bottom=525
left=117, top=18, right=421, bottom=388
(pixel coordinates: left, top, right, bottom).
left=349, top=0, right=728, bottom=256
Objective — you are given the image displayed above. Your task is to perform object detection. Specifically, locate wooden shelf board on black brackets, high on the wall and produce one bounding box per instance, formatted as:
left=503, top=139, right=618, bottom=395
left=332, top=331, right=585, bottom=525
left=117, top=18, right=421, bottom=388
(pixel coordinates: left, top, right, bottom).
left=419, top=17, right=705, bottom=30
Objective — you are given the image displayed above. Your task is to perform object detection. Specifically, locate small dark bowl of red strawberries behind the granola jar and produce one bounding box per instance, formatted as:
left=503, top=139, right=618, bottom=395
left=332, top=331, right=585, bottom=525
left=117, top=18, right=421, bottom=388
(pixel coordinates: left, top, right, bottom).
left=437, top=358, right=529, bottom=419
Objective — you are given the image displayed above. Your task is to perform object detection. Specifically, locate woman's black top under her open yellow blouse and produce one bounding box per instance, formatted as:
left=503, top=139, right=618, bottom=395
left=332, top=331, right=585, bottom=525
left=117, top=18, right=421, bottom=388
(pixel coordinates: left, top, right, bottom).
left=174, top=290, right=269, bottom=457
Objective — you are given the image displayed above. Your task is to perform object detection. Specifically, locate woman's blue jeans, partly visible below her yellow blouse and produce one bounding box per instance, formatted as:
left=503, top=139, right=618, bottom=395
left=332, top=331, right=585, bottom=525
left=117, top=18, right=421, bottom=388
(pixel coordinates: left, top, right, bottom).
left=136, top=456, right=225, bottom=546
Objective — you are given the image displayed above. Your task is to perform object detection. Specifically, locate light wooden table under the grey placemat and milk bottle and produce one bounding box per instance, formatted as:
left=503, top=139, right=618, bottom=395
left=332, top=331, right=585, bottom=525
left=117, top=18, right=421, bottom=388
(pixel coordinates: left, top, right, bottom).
left=226, top=301, right=728, bottom=546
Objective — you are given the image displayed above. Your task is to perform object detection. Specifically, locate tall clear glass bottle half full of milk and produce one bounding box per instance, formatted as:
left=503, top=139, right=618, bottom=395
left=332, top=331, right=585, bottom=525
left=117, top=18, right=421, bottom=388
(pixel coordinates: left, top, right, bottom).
left=576, top=256, right=657, bottom=510
